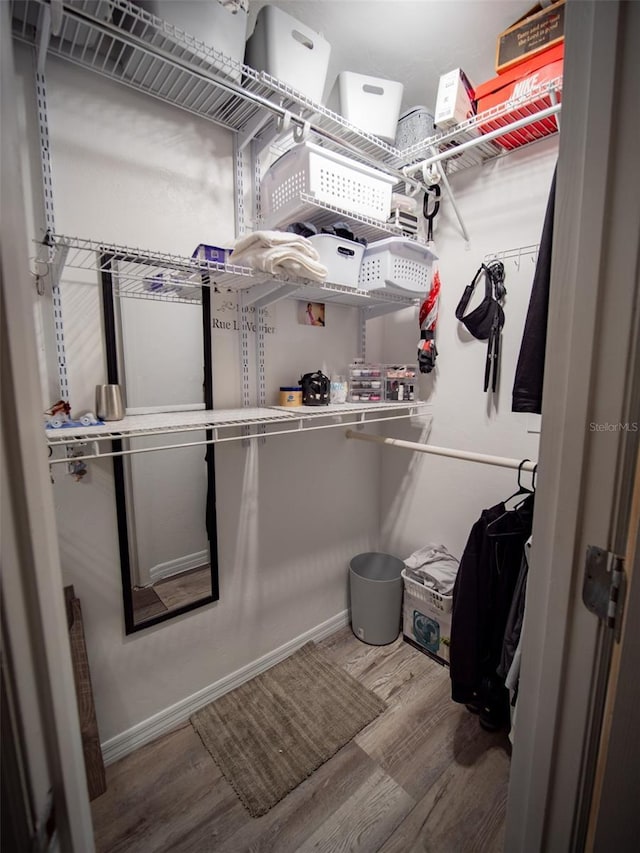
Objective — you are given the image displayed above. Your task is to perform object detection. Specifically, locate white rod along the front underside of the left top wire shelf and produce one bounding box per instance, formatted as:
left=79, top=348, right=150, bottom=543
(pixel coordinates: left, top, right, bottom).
left=53, top=4, right=424, bottom=189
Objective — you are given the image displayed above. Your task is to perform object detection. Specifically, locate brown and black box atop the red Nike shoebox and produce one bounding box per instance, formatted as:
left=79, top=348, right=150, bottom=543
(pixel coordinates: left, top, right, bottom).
left=496, top=0, right=565, bottom=74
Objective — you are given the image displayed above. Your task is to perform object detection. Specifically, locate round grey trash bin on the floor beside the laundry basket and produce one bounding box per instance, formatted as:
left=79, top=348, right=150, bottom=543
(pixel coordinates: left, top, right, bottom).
left=349, top=553, right=404, bottom=646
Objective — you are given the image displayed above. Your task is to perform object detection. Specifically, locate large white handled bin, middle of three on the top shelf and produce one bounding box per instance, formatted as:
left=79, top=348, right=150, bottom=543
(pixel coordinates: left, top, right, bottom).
left=245, top=5, right=331, bottom=103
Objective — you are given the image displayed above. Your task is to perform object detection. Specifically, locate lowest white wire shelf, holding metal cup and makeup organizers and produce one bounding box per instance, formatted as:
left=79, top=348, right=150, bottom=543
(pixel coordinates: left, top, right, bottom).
left=45, top=401, right=431, bottom=465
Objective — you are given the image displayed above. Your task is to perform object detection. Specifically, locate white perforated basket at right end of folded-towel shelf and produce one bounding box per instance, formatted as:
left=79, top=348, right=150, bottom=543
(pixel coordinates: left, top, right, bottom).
left=360, top=237, right=436, bottom=296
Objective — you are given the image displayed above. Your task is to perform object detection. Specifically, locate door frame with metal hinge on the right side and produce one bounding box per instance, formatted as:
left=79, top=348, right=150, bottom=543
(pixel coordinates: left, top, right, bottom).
left=505, top=0, right=640, bottom=853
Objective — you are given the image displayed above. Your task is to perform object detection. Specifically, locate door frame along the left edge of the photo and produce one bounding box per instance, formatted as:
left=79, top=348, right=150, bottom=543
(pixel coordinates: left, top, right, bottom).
left=0, top=3, right=94, bottom=853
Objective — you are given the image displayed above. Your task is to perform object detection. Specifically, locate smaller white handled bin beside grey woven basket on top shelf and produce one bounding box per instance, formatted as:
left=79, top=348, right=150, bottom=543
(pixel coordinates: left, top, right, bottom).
left=338, top=71, right=404, bottom=143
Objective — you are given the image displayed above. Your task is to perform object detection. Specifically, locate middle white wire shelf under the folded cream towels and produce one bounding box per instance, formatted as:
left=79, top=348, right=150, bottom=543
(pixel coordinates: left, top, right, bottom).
left=47, top=235, right=417, bottom=317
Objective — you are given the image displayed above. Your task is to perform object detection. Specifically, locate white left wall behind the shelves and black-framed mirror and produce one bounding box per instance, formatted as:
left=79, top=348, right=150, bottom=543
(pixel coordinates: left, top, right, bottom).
left=20, top=52, right=379, bottom=741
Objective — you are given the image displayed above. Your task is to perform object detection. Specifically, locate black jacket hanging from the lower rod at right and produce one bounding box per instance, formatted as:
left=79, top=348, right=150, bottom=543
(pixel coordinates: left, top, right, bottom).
left=449, top=495, right=534, bottom=703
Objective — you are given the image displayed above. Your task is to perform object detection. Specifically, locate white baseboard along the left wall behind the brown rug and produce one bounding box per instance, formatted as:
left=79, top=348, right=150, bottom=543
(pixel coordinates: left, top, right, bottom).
left=101, top=610, right=350, bottom=764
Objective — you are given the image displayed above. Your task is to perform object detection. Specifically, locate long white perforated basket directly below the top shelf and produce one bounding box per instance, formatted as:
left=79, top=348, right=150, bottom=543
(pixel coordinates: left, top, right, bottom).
left=261, top=142, right=394, bottom=228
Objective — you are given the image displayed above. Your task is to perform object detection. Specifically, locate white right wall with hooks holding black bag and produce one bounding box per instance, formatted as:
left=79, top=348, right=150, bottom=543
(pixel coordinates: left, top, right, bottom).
left=372, top=139, right=557, bottom=557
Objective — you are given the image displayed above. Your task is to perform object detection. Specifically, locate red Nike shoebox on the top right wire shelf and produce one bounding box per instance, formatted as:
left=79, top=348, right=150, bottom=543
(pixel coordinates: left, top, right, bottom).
left=476, top=43, right=564, bottom=149
